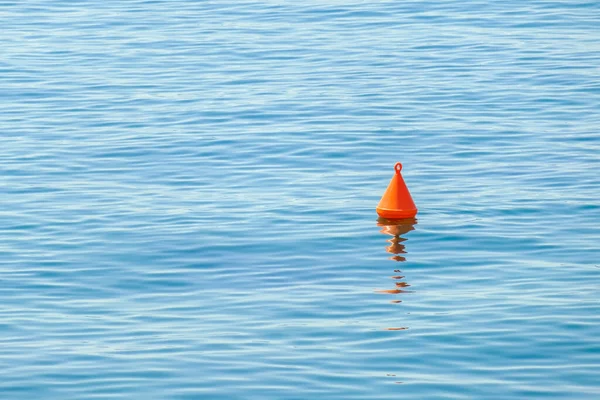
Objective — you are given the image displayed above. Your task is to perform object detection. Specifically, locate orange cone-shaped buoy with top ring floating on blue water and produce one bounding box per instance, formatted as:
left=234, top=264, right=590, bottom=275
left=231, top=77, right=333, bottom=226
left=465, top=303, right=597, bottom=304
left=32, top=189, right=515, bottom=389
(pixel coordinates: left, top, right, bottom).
left=377, top=163, right=417, bottom=219
